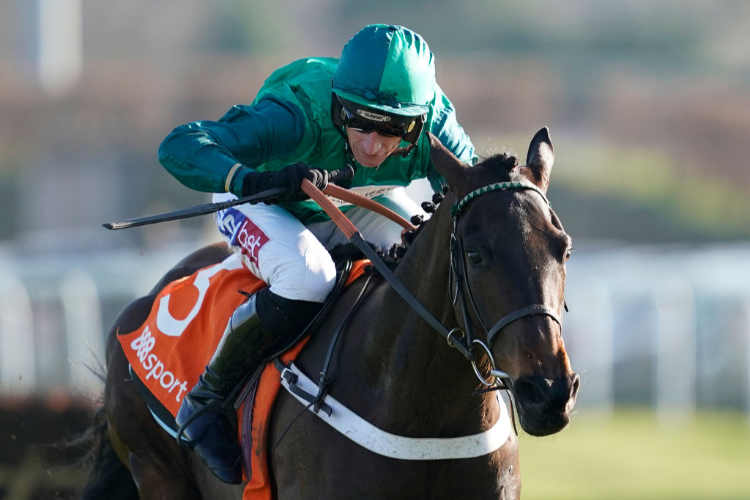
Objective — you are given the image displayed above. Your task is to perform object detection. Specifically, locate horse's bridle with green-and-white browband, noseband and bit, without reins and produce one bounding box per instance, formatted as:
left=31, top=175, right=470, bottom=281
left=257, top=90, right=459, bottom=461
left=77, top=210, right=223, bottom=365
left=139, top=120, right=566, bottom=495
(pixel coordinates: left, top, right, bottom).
left=447, top=180, right=562, bottom=386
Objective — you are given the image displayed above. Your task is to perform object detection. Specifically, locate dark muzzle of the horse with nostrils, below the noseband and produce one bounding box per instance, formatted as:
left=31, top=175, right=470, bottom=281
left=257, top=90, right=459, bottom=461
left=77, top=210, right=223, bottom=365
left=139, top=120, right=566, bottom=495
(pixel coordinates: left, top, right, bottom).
left=513, top=373, right=581, bottom=436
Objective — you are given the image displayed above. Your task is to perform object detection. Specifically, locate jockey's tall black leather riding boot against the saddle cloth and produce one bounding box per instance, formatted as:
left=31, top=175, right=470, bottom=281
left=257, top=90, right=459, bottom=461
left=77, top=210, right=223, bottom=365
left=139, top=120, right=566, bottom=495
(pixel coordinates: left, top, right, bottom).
left=176, top=288, right=322, bottom=484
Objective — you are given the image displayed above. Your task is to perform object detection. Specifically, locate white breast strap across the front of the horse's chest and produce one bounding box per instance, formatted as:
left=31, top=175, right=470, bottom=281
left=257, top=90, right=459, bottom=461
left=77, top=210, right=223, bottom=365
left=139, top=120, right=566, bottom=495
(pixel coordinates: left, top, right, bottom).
left=281, top=363, right=511, bottom=460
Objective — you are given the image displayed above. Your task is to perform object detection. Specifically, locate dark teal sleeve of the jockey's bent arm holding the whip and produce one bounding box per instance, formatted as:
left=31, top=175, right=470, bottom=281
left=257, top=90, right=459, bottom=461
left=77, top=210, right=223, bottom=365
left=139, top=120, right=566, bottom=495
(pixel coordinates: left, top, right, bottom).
left=159, top=96, right=305, bottom=196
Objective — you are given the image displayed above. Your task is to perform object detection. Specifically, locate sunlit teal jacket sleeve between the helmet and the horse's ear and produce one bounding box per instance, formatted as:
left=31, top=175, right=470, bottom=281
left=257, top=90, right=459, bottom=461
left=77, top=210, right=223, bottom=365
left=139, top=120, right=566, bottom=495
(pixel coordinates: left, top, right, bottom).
left=427, top=92, right=477, bottom=193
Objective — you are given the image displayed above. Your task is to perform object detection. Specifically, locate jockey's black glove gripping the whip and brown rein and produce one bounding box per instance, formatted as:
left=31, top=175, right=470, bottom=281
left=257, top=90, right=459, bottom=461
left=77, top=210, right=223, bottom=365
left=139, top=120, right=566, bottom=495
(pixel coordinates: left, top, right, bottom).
left=242, top=163, right=328, bottom=205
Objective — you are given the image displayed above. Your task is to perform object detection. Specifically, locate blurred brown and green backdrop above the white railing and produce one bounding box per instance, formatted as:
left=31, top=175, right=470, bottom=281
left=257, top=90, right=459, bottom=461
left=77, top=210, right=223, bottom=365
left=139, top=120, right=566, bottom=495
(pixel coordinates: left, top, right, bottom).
left=0, top=0, right=750, bottom=245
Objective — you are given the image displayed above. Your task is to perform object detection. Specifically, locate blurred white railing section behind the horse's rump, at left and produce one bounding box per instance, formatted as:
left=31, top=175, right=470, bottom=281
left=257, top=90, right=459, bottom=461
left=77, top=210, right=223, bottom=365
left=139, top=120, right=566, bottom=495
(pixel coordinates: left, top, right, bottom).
left=0, top=245, right=200, bottom=397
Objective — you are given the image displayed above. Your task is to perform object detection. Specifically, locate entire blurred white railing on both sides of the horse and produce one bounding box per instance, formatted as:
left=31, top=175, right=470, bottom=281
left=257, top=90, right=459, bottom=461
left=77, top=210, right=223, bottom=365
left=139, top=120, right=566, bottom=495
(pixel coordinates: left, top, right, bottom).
left=0, top=242, right=750, bottom=417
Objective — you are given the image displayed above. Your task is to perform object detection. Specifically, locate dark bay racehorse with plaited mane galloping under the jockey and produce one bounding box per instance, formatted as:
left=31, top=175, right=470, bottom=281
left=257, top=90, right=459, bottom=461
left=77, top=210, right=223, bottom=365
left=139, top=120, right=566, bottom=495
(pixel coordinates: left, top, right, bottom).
left=84, top=128, right=579, bottom=500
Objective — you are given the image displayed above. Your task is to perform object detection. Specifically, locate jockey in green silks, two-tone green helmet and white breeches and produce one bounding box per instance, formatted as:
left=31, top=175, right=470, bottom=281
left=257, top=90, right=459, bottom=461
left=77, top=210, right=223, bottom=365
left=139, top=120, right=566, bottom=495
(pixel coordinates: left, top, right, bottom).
left=159, top=25, right=476, bottom=483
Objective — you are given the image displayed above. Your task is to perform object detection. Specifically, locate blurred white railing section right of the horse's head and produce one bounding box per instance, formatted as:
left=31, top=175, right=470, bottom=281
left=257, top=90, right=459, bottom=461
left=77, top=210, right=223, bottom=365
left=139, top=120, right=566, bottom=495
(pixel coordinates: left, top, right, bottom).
left=564, top=240, right=750, bottom=420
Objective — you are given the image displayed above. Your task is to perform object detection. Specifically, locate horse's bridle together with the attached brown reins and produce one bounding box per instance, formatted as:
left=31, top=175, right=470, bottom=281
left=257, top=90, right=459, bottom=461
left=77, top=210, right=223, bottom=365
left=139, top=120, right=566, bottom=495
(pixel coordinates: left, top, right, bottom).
left=302, top=179, right=562, bottom=387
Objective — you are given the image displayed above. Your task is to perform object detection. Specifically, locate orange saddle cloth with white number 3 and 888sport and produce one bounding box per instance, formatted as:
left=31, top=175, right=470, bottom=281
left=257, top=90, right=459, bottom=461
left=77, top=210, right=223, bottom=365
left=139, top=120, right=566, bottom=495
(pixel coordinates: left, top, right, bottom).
left=118, top=255, right=369, bottom=500
